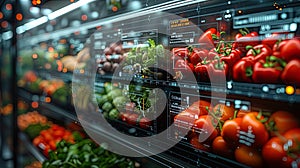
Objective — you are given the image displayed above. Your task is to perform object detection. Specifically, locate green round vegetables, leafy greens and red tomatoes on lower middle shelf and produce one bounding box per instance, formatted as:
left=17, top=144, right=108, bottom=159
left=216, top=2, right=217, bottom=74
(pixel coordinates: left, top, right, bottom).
left=96, top=82, right=154, bottom=129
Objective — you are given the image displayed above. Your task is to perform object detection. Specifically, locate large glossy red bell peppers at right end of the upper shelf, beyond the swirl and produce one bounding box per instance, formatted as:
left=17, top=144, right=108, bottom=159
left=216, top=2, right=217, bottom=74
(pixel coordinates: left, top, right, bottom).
left=233, top=33, right=300, bottom=87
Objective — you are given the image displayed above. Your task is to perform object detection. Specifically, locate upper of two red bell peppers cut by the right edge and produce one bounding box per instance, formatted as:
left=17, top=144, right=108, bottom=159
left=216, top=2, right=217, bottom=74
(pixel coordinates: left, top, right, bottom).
left=280, top=38, right=300, bottom=62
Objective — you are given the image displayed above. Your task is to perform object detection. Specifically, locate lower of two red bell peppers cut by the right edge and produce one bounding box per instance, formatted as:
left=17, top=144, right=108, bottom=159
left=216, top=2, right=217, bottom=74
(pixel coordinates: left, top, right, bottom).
left=281, top=59, right=300, bottom=87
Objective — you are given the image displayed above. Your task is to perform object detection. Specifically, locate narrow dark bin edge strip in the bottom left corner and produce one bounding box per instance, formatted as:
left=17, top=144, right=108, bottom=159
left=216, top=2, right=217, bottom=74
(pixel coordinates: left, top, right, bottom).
left=19, top=132, right=47, bottom=163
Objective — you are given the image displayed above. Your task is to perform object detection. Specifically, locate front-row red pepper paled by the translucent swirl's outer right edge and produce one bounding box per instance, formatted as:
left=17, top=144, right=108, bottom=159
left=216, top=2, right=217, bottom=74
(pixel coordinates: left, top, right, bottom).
left=208, top=57, right=229, bottom=81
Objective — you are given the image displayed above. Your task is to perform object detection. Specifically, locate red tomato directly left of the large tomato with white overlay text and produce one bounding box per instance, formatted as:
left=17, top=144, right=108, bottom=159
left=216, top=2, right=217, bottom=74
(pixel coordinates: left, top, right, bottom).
left=221, top=118, right=242, bottom=145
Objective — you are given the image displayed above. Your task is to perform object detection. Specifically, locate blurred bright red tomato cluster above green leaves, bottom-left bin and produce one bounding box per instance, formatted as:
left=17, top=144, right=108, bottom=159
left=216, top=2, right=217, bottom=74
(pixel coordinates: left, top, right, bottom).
left=33, top=124, right=75, bottom=156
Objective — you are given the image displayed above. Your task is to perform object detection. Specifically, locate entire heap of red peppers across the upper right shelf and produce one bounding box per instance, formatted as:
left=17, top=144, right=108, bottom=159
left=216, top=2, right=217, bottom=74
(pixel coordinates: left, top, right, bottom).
left=172, top=28, right=300, bottom=86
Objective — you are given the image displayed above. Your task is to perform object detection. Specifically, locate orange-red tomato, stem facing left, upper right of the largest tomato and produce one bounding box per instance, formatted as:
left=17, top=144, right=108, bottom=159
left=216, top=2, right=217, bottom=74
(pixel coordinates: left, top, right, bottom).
left=268, top=111, right=300, bottom=136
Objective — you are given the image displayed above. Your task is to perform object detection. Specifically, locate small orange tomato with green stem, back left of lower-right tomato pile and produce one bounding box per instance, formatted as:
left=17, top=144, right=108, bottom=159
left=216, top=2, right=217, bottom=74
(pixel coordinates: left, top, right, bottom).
left=213, top=104, right=234, bottom=121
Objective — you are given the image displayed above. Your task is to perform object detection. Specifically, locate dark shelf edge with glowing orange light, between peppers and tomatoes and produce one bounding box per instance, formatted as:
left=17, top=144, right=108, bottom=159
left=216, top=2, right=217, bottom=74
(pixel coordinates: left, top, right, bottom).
left=95, top=75, right=300, bottom=103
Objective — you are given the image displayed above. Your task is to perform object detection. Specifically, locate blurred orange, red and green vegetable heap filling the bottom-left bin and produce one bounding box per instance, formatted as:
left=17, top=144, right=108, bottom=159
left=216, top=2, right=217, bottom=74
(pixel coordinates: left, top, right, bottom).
left=18, top=111, right=139, bottom=168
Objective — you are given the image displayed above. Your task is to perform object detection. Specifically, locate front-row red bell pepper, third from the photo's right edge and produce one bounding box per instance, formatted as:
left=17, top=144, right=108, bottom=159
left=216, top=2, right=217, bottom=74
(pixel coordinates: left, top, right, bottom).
left=232, top=57, right=253, bottom=82
